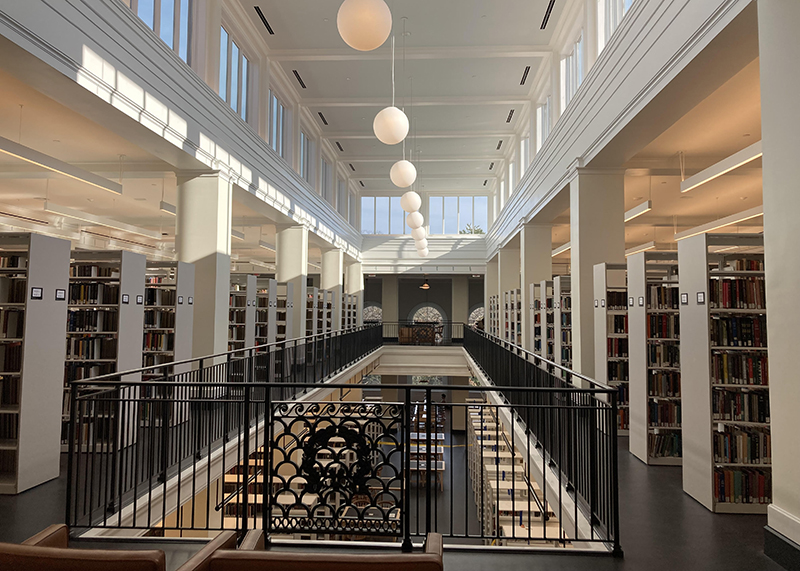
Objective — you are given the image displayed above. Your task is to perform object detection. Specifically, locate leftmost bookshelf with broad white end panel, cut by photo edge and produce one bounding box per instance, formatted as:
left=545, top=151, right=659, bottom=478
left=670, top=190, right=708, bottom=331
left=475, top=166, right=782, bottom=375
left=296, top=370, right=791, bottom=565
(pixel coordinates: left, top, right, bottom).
left=0, top=233, right=70, bottom=494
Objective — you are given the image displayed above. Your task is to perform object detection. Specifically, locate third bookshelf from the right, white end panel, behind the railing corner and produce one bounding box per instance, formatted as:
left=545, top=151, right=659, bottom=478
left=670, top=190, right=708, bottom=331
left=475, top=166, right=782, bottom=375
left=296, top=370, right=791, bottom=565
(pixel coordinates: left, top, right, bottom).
left=594, top=263, right=630, bottom=436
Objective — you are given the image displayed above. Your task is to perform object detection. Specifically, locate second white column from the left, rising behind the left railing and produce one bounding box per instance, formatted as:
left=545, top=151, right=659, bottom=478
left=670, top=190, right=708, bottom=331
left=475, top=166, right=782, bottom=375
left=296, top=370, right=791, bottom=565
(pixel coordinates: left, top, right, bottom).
left=275, top=226, right=308, bottom=337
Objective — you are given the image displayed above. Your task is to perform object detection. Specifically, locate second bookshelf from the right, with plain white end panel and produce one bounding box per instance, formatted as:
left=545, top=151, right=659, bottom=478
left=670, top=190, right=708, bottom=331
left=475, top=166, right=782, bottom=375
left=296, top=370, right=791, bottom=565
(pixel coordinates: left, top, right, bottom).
left=628, top=252, right=683, bottom=466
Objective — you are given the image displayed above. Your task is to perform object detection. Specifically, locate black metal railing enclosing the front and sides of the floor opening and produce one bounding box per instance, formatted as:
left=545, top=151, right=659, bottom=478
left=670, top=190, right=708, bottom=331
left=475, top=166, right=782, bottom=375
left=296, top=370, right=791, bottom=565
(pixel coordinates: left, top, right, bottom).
left=67, top=327, right=619, bottom=552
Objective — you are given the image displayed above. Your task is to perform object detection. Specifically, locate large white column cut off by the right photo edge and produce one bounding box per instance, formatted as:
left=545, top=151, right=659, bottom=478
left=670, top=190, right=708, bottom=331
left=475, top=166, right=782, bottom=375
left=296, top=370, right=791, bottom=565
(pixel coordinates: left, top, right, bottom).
left=758, top=0, right=800, bottom=556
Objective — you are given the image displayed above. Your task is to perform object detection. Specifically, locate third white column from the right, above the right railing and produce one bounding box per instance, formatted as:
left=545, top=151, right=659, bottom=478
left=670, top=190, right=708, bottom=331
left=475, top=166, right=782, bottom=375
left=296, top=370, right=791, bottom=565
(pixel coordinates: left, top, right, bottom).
left=519, top=223, right=553, bottom=351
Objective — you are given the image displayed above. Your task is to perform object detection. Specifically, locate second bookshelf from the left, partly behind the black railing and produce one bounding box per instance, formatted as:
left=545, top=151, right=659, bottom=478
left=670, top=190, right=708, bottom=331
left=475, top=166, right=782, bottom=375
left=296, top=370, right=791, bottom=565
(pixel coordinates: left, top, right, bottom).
left=61, top=250, right=146, bottom=451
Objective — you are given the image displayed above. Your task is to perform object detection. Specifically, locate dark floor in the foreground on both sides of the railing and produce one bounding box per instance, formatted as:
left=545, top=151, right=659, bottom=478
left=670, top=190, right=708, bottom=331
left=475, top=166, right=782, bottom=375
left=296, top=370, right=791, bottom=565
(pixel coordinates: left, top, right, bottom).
left=0, top=440, right=782, bottom=571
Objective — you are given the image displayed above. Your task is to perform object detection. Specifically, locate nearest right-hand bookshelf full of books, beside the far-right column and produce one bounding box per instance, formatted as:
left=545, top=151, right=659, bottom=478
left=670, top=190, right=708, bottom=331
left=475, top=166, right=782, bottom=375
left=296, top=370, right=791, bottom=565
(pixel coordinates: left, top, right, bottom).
left=678, top=234, right=772, bottom=514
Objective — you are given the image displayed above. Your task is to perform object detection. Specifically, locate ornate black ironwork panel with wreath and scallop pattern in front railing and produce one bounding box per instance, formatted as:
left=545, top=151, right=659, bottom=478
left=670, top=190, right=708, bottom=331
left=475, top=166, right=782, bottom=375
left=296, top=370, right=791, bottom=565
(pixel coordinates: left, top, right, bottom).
left=267, top=402, right=405, bottom=539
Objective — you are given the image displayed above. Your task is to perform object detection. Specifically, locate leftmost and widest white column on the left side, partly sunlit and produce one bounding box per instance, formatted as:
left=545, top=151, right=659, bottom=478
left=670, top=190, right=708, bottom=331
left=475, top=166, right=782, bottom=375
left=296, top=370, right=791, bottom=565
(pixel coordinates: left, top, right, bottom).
left=175, top=174, right=232, bottom=357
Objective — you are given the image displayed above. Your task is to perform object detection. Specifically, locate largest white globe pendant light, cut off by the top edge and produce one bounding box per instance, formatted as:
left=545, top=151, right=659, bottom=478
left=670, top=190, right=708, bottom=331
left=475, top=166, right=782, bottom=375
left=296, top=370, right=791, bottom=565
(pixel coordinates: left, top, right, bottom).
left=336, top=0, right=392, bottom=52
